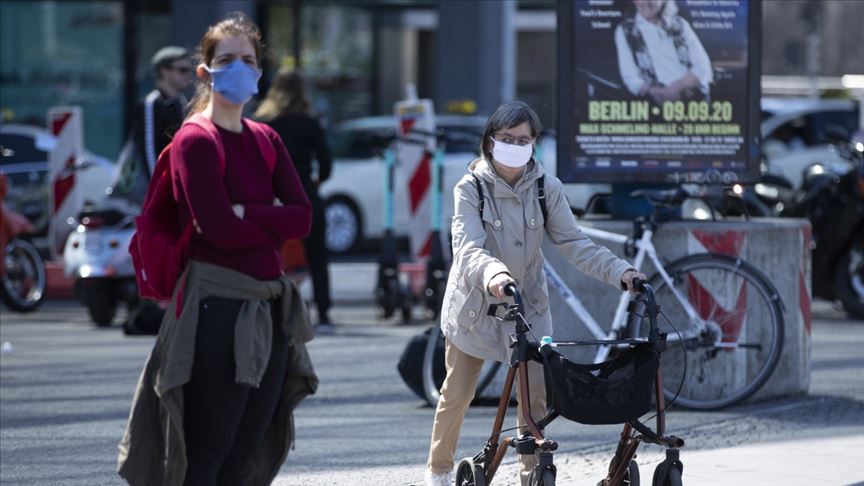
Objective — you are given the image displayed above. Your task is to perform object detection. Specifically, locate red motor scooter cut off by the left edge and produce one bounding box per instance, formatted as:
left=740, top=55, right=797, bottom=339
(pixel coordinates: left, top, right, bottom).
left=0, top=174, right=48, bottom=312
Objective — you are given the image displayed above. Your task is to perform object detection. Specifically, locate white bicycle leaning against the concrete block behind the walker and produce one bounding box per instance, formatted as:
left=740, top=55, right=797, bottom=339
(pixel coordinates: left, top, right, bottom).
left=423, top=189, right=784, bottom=410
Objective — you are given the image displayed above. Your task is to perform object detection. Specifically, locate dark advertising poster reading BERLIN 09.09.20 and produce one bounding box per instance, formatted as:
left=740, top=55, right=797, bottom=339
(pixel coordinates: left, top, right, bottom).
left=558, top=0, right=759, bottom=184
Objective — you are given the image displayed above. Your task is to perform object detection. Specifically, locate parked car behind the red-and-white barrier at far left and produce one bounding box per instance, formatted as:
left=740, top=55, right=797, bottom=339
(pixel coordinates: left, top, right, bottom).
left=0, top=124, right=115, bottom=247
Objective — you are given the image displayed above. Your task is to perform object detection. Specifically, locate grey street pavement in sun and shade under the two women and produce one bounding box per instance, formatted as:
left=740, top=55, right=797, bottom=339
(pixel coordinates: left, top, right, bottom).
left=0, top=263, right=864, bottom=486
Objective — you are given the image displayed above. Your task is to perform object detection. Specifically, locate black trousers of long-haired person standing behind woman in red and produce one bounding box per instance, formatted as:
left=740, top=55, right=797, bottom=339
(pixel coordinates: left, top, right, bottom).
left=303, top=186, right=331, bottom=320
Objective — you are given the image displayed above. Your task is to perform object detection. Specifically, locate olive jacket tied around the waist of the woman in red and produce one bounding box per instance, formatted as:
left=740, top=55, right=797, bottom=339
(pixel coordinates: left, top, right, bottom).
left=118, top=260, right=318, bottom=486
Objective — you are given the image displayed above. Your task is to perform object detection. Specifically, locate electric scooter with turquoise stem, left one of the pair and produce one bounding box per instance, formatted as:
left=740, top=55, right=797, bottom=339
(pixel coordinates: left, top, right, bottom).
left=375, top=149, right=412, bottom=323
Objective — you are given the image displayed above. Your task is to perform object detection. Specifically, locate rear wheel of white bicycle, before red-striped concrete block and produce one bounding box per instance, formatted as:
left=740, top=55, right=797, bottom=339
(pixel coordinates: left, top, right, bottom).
left=628, top=254, right=783, bottom=410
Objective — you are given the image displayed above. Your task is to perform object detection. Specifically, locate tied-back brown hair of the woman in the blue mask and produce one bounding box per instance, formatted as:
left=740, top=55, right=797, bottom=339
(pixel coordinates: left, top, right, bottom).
left=187, top=12, right=264, bottom=117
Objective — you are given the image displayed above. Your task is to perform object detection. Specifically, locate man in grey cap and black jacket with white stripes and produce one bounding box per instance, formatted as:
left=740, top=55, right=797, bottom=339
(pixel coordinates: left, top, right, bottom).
left=122, top=46, right=192, bottom=335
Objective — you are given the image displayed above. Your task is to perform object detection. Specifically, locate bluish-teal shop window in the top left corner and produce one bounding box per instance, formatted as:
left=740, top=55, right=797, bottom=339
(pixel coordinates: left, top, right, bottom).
left=0, top=0, right=124, bottom=159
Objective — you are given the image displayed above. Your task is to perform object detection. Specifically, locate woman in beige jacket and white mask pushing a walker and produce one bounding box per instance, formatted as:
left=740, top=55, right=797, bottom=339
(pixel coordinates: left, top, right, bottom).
left=426, top=101, right=645, bottom=486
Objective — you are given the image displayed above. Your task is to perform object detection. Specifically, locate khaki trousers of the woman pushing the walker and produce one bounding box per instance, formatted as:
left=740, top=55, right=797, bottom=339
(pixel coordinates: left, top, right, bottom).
left=426, top=340, right=546, bottom=484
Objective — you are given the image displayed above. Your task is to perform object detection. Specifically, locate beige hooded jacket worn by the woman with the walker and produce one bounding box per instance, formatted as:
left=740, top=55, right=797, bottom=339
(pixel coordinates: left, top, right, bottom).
left=441, top=159, right=632, bottom=361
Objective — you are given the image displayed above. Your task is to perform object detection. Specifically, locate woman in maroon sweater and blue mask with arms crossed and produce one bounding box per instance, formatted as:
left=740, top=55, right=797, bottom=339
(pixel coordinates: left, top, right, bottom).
left=119, top=13, right=317, bottom=486
